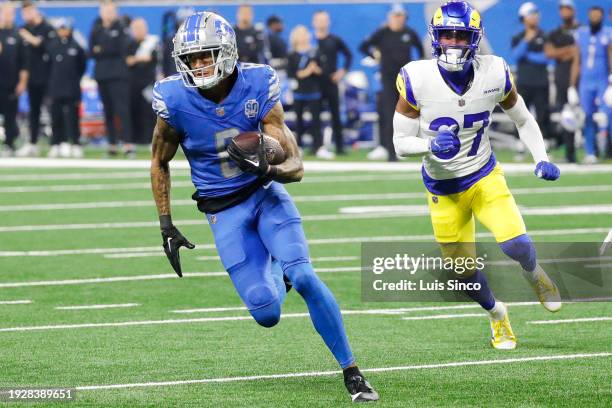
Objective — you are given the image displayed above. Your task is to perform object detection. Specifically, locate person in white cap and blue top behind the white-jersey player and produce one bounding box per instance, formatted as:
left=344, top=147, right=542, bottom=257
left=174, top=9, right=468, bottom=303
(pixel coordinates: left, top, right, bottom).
left=512, top=2, right=552, bottom=156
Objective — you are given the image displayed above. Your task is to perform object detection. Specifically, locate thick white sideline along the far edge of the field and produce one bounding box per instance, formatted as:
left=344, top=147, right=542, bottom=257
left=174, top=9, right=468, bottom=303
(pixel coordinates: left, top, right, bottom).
left=0, top=158, right=612, bottom=174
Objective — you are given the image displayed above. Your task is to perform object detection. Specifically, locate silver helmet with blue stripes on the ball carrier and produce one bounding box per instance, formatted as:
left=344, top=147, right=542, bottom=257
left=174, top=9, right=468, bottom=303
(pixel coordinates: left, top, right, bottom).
left=172, top=11, right=238, bottom=89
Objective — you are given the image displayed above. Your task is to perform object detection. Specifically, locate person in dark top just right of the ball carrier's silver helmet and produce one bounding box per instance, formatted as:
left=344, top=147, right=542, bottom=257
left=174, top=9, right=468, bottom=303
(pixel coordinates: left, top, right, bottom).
left=234, top=6, right=266, bottom=64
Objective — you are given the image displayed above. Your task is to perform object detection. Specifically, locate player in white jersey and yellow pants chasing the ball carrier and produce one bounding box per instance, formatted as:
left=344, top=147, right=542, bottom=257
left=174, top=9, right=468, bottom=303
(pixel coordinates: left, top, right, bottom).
left=393, top=1, right=561, bottom=349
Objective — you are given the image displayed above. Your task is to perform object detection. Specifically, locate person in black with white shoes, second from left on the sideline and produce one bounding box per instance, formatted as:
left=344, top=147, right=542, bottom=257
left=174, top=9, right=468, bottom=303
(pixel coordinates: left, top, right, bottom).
left=17, top=0, right=55, bottom=157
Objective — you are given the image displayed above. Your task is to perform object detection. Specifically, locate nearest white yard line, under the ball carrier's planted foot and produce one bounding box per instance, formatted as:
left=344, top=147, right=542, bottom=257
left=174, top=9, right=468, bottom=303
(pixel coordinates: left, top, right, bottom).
left=75, top=352, right=612, bottom=391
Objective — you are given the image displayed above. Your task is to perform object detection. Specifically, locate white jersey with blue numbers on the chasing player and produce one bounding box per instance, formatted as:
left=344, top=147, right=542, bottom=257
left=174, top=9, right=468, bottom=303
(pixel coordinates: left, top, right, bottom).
left=397, top=55, right=512, bottom=180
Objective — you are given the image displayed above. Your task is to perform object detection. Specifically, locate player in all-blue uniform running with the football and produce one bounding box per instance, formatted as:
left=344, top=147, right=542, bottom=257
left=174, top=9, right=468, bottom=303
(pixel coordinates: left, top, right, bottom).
left=151, top=12, right=378, bottom=401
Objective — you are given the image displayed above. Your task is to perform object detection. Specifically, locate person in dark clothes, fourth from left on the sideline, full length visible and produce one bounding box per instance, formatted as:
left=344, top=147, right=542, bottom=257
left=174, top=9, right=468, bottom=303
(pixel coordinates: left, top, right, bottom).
left=89, top=1, right=134, bottom=156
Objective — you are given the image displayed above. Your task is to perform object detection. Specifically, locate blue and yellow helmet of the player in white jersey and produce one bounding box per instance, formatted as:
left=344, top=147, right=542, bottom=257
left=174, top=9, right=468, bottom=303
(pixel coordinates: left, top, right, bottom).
left=429, top=1, right=484, bottom=71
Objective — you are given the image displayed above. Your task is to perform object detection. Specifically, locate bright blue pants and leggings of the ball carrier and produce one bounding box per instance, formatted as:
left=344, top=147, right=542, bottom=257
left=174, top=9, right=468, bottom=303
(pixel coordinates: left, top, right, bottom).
left=207, top=182, right=354, bottom=368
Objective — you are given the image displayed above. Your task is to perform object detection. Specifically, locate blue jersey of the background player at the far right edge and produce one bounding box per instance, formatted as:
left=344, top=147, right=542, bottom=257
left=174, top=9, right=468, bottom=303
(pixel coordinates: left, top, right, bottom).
left=575, top=26, right=612, bottom=82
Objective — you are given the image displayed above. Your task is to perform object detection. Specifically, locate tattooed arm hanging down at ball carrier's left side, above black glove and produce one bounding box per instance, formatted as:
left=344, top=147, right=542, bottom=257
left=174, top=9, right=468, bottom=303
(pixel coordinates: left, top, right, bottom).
left=151, top=118, right=180, bottom=216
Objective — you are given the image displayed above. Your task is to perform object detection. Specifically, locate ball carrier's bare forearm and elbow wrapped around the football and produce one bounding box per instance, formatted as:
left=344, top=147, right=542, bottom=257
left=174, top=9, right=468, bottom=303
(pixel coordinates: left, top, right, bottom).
left=262, top=102, right=304, bottom=183
